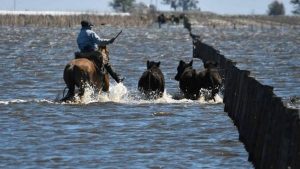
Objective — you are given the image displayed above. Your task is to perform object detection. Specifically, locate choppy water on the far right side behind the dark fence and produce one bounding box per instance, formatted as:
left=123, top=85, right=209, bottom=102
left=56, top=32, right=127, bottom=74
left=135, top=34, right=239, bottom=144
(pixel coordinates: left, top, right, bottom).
left=194, top=26, right=300, bottom=109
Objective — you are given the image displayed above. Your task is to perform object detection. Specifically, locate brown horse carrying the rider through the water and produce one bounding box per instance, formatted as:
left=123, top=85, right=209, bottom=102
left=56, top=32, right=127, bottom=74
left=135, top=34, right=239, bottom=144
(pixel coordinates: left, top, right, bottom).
left=61, top=47, right=109, bottom=102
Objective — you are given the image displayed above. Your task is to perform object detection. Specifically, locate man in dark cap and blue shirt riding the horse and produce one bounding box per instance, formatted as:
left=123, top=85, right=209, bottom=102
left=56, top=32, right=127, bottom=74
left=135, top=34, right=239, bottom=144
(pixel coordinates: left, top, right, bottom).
left=77, top=20, right=124, bottom=83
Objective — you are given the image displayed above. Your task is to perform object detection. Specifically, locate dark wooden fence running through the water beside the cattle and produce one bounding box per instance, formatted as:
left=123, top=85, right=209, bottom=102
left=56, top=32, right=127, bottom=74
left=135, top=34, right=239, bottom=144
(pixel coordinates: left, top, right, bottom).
left=193, top=38, right=300, bottom=169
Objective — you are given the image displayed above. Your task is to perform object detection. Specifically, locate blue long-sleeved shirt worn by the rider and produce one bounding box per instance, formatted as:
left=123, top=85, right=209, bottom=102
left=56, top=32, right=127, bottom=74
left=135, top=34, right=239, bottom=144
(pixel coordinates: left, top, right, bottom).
left=77, top=28, right=110, bottom=52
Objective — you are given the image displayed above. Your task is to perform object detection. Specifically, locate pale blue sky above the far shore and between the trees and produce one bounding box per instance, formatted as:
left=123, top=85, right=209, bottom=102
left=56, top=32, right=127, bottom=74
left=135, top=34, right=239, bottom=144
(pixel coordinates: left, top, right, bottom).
left=0, top=0, right=293, bottom=14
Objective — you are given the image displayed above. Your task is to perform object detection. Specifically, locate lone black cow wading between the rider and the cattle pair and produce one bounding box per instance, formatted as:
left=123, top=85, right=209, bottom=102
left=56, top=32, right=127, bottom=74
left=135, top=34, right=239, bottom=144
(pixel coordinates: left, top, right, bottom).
left=138, top=61, right=165, bottom=99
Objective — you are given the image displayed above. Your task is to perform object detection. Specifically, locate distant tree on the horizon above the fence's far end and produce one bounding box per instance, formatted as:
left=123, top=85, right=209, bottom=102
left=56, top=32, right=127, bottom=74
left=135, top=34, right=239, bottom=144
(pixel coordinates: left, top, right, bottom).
left=163, top=0, right=199, bottom=11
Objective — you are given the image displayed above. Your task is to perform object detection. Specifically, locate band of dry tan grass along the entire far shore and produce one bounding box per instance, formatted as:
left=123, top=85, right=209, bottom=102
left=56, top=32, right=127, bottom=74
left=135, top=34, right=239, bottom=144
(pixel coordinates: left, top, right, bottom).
left=0, top=12, right=300, bottom=28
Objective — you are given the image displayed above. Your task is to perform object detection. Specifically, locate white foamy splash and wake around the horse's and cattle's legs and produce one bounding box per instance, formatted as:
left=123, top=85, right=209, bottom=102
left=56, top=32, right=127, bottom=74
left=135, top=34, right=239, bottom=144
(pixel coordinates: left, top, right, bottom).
left=0, top=83, right=223, bottom=105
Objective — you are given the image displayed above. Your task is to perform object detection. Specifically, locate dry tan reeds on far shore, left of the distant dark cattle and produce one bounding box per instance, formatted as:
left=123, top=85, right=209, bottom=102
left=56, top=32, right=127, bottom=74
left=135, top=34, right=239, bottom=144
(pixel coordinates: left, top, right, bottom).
left=0, top=14, right=153, bottom=27
